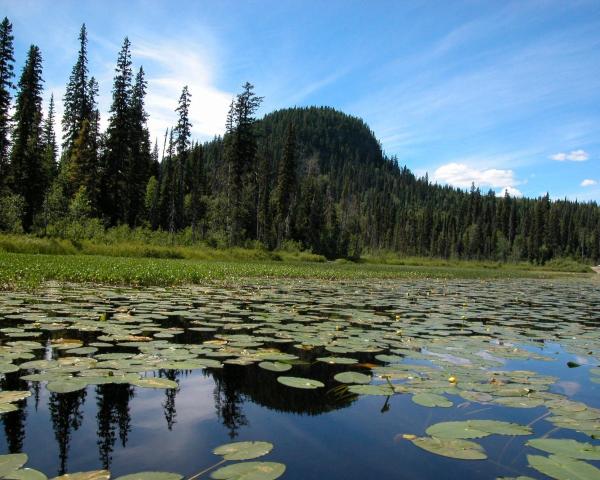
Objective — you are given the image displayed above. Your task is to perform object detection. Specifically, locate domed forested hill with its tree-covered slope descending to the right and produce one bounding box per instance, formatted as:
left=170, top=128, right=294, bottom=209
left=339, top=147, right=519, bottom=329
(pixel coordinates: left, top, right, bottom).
left=200, top=107, right=600, bottom=262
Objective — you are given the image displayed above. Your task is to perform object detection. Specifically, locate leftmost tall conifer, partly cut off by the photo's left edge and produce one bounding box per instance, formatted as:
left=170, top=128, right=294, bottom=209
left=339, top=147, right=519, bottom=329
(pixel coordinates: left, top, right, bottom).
left=0, top=17, right=15, bottom=194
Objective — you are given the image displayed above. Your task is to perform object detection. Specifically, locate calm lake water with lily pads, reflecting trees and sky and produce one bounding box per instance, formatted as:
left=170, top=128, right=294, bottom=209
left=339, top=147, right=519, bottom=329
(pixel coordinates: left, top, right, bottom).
left=0, top=280, right=600, bottom=479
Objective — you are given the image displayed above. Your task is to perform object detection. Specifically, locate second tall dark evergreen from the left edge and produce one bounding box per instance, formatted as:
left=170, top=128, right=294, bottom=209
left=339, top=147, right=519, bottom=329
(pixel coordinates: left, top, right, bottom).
left=10, top=45, right=47, bottom=230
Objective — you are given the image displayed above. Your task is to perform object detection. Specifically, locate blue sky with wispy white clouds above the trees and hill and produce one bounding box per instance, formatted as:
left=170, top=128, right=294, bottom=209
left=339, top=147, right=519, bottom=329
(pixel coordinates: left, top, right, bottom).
left=2, top=0, right=600, bottom=201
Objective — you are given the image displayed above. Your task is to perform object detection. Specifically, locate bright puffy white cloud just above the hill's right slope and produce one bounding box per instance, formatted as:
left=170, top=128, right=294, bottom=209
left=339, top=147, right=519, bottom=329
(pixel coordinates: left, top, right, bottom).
left=432, top=162, right=518, bottom=190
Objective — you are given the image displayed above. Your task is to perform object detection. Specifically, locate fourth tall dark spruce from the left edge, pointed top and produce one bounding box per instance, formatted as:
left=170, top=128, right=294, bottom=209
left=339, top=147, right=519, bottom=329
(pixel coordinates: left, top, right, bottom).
left=101, top=37, right=133, bottom=225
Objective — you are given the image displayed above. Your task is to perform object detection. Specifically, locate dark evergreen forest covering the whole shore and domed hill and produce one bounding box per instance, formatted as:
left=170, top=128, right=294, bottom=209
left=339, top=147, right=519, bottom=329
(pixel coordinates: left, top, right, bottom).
left=0, top=18, right=600, bottom=263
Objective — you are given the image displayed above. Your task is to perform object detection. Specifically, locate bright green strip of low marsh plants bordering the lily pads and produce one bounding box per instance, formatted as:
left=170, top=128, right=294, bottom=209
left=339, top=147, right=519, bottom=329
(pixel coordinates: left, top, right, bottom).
left=0, top=252, right=585, bottom=289
